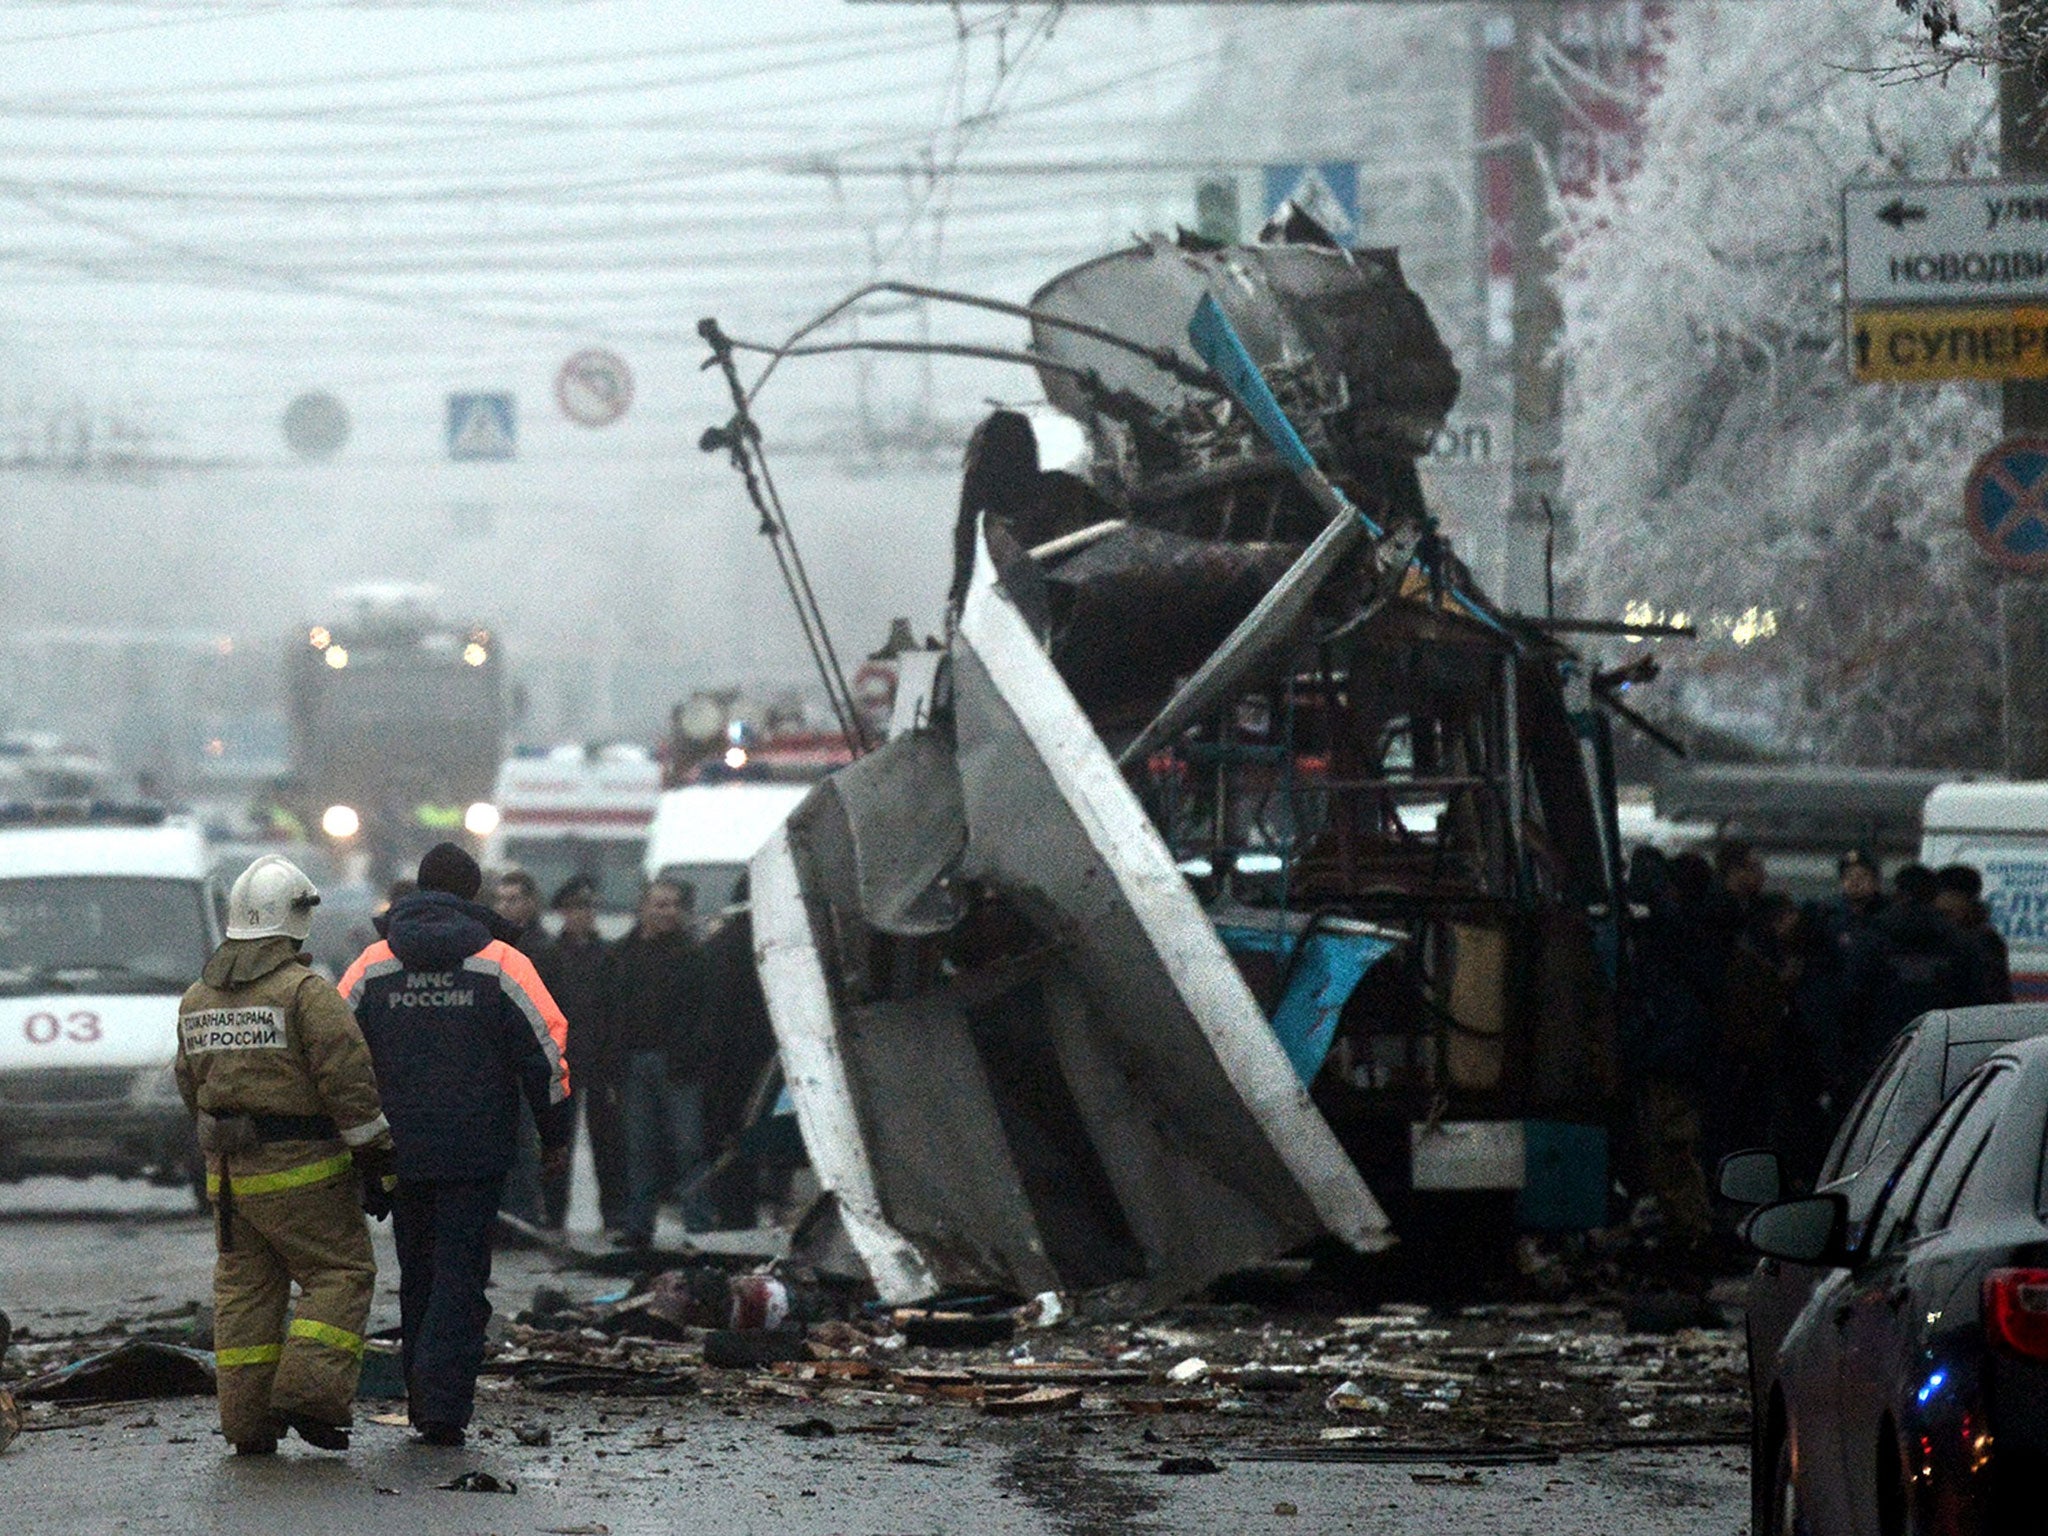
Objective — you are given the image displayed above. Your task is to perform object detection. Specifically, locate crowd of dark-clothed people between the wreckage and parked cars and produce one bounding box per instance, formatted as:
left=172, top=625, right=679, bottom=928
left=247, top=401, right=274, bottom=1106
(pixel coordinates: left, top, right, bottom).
left=1624, top=840, right=2013, bottom=1266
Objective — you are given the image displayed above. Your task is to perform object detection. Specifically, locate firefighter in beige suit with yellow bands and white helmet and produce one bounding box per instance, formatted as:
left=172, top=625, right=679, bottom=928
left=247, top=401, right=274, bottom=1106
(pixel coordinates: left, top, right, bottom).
left=178, top=854, right=391, bottom=1456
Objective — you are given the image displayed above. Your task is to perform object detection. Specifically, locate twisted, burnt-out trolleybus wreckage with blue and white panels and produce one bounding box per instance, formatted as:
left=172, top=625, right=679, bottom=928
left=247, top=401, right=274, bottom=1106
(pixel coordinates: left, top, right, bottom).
left=702, top=219, right=1646, bottom=1300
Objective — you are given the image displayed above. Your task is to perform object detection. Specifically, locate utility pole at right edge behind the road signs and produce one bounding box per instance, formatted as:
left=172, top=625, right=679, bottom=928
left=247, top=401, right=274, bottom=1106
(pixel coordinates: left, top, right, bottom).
left=1999, top=0, right=2048, bottom=778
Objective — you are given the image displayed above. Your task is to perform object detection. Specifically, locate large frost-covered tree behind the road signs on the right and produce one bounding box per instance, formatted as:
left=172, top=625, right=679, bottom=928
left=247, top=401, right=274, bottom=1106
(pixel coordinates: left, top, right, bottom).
left=1563, top=0, right=1999, bottom=766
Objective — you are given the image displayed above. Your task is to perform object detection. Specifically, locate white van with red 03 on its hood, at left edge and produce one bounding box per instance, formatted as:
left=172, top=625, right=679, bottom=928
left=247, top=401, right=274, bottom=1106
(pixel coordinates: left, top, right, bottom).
left=0, top=805, right=221, bottom=1184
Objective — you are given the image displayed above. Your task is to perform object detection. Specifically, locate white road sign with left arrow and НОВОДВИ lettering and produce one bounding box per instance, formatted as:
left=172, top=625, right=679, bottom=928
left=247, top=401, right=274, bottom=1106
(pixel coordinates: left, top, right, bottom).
left=1841, top=178, right=2048, bottom=309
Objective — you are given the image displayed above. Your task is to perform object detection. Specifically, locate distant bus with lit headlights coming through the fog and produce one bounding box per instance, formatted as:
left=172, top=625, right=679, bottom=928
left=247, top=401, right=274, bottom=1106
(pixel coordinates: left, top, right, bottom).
left=287, top=586, right=506, bottom=883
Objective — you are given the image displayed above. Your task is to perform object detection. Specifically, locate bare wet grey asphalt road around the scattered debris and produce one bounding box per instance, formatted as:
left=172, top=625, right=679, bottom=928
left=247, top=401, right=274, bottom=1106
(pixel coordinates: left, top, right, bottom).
left=0, top=1182, right=1747, bottom=1536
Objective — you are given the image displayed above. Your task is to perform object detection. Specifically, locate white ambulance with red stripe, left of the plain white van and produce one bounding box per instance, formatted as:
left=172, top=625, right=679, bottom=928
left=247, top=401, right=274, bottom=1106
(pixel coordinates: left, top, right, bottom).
left=483, top=743, right=662, bottom=938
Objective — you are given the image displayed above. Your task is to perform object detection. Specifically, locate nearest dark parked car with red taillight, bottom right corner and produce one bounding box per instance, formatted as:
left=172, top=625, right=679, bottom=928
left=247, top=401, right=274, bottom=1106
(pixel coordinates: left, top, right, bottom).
left=1743, top=1036, right=2048, bottom=1536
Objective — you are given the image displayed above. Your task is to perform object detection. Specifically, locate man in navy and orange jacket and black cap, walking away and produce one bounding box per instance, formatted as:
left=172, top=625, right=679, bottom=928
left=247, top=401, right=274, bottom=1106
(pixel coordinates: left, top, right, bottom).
left=340, top=842, right=569, bottom=1446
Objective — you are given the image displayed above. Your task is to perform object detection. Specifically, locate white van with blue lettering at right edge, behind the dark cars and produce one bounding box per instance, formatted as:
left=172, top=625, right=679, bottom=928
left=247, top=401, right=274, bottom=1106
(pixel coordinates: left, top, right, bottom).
left=1921, top=782, right=2048, bottom=1001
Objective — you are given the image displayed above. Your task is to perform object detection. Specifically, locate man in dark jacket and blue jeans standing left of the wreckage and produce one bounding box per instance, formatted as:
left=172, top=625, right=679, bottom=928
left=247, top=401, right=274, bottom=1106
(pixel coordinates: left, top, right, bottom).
left=604, top=879, right=711, bottom=1247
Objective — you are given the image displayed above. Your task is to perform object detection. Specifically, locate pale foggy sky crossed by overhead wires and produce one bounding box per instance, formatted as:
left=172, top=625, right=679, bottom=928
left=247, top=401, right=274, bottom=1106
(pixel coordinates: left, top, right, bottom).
left=0, top=0, right=1474, bottom=745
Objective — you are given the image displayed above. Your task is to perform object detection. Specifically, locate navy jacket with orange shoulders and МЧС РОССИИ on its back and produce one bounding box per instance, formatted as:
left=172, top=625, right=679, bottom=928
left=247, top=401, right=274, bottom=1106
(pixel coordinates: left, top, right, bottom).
left=342, top=891, right=573, bottom=1182
